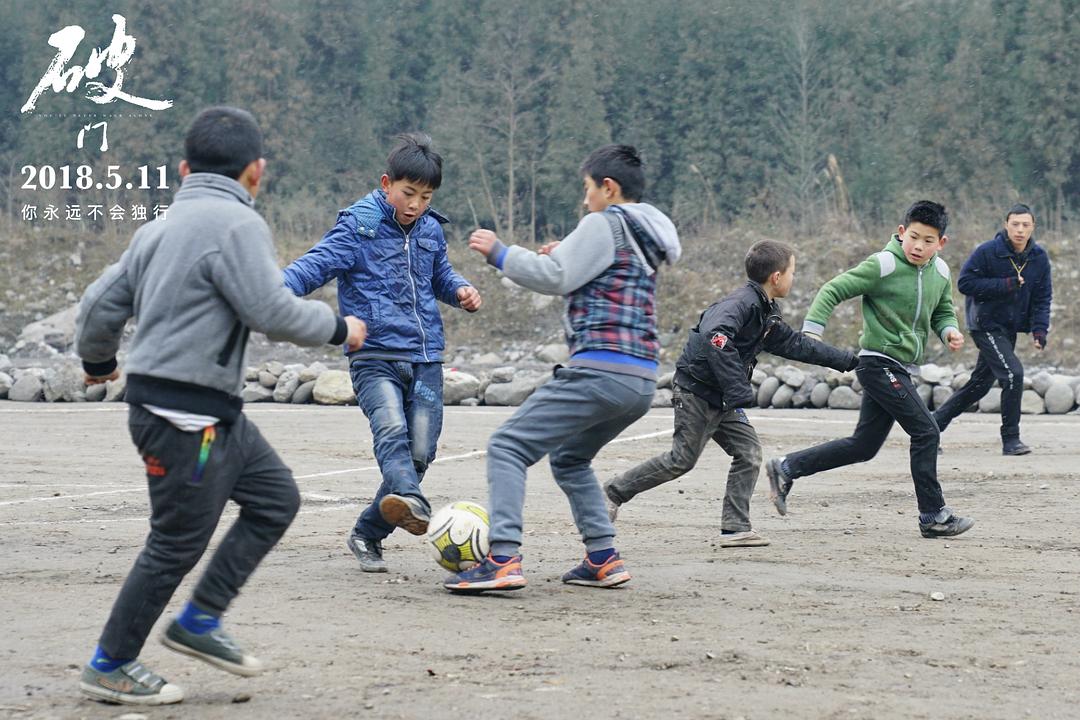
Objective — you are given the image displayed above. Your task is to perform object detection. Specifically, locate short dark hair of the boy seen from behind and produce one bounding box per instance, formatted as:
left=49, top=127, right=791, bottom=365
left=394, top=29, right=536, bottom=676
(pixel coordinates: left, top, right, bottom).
left=184, top=107, right=262, bottom=180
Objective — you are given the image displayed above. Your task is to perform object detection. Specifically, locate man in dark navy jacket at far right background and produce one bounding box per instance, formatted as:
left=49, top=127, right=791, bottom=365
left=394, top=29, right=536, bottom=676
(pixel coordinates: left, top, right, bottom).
left=934, top=205, right=1053, bottom=456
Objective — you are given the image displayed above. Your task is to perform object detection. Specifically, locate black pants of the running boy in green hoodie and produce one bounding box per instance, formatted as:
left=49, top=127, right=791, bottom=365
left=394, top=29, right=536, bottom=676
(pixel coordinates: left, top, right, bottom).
left=787, top=355, right=945, bottom=513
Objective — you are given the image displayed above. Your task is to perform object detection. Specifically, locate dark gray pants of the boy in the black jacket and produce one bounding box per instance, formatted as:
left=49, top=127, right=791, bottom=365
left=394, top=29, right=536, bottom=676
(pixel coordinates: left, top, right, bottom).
left=607, top=384, right=761, bottom=532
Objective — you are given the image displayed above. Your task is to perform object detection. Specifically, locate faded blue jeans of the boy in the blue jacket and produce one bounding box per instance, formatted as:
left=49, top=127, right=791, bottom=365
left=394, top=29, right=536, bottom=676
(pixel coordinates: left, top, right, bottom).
left=350, top=359, right=443, bottom=540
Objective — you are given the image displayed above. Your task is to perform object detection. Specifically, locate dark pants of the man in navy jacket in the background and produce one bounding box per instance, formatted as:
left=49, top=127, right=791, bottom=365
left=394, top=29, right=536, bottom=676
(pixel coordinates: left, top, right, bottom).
left=934, top=330, right=1024, bottom=440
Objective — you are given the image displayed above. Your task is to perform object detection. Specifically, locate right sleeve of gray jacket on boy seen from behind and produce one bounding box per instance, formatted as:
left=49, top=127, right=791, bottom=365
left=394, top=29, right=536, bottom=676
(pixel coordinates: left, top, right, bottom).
left=213, top=217, right=337, bottom=345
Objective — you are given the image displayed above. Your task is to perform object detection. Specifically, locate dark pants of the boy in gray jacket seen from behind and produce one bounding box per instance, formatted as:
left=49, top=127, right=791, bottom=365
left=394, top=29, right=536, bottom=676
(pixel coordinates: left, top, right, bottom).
left=98, top=406, right=300, bottom=658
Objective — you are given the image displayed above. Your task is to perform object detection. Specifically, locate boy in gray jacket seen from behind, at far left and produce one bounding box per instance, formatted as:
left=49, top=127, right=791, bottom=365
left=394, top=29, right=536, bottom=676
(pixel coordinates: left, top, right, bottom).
left=76, top=107, right=366, bottom=705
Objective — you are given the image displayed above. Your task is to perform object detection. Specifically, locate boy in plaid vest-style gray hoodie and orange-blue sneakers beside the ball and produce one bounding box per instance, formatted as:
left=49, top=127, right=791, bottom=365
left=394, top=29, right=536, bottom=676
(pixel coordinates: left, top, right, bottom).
left=443, top=145, right=680, bottom=593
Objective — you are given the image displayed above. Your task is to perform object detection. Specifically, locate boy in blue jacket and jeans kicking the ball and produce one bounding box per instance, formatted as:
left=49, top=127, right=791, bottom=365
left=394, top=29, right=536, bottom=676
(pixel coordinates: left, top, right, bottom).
left=284, top=134, right=481, bottom=572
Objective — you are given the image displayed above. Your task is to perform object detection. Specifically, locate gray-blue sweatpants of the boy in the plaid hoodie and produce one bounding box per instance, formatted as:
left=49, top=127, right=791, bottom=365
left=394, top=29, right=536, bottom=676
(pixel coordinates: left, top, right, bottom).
left=487, top=367, right=657, bottom=555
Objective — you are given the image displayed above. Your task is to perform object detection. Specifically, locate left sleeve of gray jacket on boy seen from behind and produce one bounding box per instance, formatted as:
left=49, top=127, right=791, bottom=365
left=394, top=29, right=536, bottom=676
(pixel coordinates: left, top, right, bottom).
left=75, top=248, right=135, bottom=376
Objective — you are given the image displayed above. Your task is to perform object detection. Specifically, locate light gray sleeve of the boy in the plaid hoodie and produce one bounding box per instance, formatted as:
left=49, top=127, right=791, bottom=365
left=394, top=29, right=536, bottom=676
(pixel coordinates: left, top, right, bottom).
left=489, top=213, right=615, bottom=295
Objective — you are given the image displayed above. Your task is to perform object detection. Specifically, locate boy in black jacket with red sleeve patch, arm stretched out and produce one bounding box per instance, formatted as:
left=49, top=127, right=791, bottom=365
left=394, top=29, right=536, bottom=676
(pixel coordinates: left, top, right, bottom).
left=604, top=240, right=856, bottom=547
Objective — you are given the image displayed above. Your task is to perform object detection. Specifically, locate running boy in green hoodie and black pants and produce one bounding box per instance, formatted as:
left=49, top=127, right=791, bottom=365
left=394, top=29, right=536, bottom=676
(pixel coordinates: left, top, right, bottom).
left=766, top=200, right=975, bottom=538
